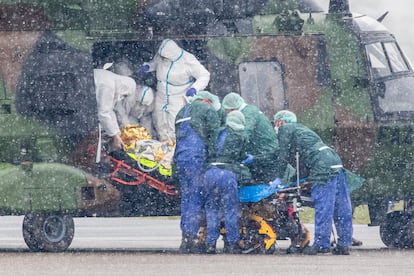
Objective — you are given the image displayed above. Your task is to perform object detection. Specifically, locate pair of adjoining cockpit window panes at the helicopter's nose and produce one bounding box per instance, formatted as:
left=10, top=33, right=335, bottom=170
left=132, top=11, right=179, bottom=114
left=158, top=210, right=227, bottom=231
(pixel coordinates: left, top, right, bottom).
left=366, top=42, right=409, bottom=78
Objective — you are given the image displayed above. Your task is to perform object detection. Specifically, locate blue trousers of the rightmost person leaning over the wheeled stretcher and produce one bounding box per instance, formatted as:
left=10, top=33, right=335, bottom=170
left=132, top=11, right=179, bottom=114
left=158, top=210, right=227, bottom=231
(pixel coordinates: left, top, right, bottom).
left=311, top=170, right=352, bottom=248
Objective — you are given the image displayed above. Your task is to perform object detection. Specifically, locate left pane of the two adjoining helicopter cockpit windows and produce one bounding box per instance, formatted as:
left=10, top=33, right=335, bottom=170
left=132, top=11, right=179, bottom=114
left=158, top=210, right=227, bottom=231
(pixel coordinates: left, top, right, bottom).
left=366, top=43, right=391, bottom=78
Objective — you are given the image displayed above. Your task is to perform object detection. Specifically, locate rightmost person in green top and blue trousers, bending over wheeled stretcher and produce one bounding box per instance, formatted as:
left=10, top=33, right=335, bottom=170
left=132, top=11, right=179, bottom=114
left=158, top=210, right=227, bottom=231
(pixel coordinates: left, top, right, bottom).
left=274, top=110, right=352, bottom=255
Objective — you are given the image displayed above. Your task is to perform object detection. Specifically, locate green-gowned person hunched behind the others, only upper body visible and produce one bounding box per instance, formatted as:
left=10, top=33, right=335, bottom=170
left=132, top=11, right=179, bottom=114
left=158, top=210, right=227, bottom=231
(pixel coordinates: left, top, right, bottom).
left=222, top=92, right=279, bottom=183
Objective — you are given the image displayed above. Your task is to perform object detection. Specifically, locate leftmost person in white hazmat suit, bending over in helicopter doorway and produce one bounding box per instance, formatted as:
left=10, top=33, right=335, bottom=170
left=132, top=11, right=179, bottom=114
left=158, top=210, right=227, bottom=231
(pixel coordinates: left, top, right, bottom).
left=94, top=69, right=152, bottom=150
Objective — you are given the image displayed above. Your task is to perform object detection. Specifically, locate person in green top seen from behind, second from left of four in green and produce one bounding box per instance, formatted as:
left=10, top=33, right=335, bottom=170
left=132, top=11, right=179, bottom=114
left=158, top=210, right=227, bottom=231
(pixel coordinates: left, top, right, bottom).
left=204, top=110, right=250, bottom=254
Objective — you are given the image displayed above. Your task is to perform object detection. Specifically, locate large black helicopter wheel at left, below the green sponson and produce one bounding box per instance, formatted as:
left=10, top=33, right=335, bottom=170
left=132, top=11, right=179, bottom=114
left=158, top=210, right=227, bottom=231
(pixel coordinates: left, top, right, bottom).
left=23, top=213, right=75, bottom=252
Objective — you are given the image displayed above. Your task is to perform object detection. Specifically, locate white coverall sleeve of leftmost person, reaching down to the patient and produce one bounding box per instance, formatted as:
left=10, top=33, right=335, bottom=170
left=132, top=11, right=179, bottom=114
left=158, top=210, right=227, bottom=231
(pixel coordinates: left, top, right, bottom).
left=96, top=84, right=120, bottom=137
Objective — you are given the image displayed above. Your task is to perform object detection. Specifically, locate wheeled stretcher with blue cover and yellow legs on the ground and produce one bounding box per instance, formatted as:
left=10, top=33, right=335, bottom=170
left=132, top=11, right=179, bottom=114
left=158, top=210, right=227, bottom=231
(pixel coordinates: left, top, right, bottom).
left=233, top=179, right=310, bottom=254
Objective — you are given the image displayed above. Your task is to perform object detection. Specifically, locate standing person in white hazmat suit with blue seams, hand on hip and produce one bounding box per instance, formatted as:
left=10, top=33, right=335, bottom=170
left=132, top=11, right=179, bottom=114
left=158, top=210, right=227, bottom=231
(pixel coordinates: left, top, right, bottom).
left=140, top=39, right=210, bottom=141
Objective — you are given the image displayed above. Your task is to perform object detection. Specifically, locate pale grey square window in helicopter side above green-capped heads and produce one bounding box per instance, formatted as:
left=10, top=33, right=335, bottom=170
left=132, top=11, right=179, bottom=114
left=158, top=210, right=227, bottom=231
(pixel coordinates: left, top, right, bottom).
left=239, top=61, right=285, bottom=118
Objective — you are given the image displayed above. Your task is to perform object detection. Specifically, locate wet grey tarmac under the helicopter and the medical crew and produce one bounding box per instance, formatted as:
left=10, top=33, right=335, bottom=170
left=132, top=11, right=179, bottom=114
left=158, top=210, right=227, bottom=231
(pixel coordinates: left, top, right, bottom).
left=0, top=217, right=414, bottom=276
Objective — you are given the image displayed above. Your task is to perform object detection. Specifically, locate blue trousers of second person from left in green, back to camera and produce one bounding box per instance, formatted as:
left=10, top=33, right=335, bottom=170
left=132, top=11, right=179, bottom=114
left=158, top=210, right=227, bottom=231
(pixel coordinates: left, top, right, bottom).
left=204, top=167, right=240, bottom=245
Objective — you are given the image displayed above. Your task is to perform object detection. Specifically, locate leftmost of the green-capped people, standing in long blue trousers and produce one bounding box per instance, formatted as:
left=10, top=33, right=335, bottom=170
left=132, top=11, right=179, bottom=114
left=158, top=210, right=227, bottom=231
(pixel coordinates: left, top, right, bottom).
left=173, top=91, right=220, bottom=253
